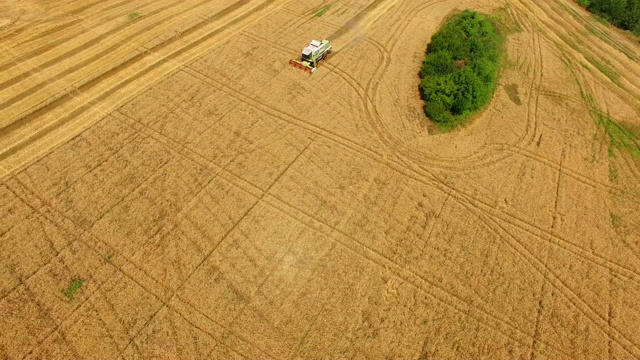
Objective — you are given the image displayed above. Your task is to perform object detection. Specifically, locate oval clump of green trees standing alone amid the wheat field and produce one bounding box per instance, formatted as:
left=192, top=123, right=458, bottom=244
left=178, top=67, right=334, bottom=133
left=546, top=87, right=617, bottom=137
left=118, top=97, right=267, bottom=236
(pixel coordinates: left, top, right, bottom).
left=420, top=10, right=504, bottom=130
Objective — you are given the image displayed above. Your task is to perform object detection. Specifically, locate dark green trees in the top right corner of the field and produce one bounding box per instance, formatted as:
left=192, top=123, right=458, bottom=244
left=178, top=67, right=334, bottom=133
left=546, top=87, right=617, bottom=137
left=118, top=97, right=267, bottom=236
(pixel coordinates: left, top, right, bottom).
left=577, top=0, right=640, bottom=35
